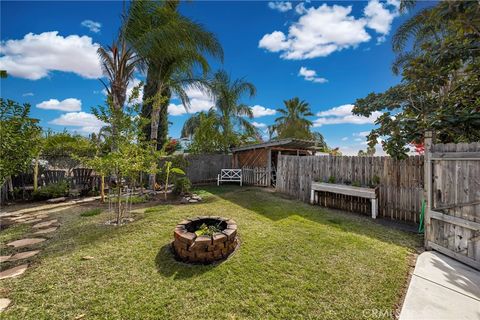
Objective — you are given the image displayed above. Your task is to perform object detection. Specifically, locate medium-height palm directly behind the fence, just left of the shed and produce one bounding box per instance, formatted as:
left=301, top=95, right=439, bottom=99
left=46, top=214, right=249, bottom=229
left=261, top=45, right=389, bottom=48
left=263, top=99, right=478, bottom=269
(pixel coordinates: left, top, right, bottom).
left=182, top=70, right=257, bottom=152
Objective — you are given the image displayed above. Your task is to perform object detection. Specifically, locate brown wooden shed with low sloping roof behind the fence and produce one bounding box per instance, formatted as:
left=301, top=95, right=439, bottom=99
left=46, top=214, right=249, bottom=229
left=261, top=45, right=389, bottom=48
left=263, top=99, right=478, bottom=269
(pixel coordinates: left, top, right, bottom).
left=232, top=139, right=316, bottom=187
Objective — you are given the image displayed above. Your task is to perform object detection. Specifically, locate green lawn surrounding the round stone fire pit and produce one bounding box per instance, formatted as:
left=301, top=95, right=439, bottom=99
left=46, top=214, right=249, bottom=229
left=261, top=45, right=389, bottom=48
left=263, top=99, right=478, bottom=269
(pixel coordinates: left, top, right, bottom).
left=2, top=186, right=420, bottom=319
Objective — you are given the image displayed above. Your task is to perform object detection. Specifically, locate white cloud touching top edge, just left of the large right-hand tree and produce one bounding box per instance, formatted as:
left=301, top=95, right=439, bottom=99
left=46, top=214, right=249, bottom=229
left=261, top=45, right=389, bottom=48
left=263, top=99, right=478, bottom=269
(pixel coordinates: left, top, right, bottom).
left=363, top=0, right=399, bottom=38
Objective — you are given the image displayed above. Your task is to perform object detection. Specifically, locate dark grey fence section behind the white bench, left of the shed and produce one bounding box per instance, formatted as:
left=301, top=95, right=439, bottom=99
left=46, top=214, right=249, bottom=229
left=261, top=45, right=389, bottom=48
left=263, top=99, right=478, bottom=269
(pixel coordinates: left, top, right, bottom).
left=185, top=154, right=232, bottom=184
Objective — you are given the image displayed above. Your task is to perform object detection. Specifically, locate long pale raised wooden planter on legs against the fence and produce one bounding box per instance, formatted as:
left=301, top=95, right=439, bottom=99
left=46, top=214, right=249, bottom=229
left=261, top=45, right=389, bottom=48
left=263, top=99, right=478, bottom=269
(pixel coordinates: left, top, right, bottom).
left=310, top=182, right=378, bottom=219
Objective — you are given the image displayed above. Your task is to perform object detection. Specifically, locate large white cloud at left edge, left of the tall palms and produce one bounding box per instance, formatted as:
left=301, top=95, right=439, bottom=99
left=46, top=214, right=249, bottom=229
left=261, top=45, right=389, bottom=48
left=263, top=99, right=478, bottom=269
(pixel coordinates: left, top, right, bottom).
left=0, top=31, right=102, bottom=80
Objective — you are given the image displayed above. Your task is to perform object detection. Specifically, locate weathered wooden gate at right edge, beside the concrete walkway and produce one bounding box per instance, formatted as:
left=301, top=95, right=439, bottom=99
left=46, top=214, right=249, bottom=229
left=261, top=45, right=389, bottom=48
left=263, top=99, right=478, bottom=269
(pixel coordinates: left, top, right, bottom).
left=425, top=134, right=480, bottom=270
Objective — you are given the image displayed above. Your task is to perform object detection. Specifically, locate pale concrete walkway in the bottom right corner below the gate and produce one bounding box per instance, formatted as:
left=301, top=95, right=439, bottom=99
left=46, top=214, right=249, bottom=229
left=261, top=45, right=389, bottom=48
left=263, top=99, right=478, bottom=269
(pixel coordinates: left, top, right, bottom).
left=400, top=251, right=480, bottom=320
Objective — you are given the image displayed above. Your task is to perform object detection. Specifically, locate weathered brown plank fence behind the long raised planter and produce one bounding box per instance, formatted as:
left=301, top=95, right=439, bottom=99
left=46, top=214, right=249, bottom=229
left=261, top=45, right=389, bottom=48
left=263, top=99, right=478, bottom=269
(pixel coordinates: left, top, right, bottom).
left=276, top=156, right=424, bottom=223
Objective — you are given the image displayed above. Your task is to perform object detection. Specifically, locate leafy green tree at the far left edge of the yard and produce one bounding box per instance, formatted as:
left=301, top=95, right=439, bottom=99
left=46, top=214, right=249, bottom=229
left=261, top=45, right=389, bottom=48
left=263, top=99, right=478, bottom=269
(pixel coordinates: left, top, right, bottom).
left=0, top=98, right=41, bottom=185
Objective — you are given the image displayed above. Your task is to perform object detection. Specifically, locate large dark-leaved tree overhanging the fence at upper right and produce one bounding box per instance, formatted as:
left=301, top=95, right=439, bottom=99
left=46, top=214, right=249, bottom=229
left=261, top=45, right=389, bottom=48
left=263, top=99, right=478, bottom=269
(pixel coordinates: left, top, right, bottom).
left=353, top=1, right=480, bottom=158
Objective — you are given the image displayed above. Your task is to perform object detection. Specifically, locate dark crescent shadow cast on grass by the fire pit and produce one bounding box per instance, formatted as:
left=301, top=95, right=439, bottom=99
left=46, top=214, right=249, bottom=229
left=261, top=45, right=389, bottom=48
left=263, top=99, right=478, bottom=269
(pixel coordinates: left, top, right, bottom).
left=155, top=243, right=219, bottom=280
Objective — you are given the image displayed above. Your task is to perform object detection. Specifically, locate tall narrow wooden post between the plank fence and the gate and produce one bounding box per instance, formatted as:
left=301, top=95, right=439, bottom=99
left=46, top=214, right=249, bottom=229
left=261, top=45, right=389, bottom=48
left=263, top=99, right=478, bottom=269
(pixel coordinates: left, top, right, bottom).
left=423, top=131, right=433, bottom=250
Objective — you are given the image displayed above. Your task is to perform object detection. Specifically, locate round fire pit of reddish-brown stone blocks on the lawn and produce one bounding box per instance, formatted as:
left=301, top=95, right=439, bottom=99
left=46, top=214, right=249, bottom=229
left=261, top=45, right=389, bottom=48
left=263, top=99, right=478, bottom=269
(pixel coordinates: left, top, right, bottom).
left=173, top=216, right=238, bottom=263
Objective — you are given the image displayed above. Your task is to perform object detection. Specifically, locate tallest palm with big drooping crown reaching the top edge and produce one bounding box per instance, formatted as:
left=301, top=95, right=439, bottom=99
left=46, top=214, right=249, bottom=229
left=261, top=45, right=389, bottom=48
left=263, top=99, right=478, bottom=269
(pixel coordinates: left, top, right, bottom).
left=125, top=0, right=223, bottom=149
